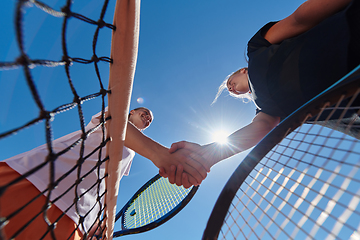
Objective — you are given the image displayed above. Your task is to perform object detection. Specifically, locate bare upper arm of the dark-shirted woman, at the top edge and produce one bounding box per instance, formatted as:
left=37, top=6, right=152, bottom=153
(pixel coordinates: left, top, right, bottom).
left=264, top=0, right=351, bottom=44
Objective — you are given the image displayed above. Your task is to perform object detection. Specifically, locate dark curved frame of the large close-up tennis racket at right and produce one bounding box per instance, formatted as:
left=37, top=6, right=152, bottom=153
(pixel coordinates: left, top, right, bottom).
left=202, top=65, right=360, bottom=240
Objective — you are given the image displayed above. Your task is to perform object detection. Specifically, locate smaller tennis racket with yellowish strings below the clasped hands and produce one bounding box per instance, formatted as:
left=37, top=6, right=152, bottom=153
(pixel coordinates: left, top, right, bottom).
left=113, top=174, right=199, bottom=237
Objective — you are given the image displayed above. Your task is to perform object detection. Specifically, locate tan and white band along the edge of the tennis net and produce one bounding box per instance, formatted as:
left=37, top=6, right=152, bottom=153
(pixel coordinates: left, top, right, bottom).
left=106, top=0, right=140, bottom=239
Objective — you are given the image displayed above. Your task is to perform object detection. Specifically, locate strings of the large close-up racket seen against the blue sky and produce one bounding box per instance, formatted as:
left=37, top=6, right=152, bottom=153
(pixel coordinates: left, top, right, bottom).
left=221, top=125, right=360, bottom=239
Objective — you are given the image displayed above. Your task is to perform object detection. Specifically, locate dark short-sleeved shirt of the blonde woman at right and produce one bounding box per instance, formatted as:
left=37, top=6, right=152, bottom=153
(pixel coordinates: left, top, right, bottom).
left=248, top=0, right=360, bottom=119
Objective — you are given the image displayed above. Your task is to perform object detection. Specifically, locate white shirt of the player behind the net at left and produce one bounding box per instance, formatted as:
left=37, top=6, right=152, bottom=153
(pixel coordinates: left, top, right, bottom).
left=4, top=109, right=135, bottom=231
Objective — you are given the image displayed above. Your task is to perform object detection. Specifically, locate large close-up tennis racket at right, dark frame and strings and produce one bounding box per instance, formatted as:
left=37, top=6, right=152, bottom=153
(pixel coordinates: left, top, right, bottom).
left=203, top=66, right=360, bottom=239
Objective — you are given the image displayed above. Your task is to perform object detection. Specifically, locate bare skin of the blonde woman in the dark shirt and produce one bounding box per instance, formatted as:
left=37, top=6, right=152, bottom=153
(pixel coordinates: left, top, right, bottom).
left=159, top=0, right=351, bottom=187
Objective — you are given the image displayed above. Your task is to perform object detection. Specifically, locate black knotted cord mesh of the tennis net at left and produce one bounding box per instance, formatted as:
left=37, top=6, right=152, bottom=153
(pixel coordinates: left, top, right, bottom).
left=0, top=0, right=115, bottom=239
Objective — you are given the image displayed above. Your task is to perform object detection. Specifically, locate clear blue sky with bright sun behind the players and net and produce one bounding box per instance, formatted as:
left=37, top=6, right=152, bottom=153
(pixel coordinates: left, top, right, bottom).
left=0, top=0, right=303, bottom=239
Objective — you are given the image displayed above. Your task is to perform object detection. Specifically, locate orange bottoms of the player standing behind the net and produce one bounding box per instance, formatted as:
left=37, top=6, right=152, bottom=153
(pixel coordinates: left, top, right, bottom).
left=0, top=162, right=82, bottom=240
